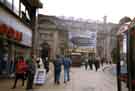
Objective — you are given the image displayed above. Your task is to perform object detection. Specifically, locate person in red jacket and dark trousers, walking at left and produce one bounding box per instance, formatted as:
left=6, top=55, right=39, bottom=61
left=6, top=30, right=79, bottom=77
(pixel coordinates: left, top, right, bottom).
left=12, top=56, right=28, bottom=89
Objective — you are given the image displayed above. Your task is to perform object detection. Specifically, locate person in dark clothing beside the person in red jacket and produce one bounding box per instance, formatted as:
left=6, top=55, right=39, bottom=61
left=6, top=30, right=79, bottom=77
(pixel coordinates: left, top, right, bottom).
left=26, top=53, right=36, bottom=90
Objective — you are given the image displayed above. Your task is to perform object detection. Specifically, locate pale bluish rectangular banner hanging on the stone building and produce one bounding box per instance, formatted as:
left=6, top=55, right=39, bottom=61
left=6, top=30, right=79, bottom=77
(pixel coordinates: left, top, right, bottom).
left=69, top=31, right=97, bottom=48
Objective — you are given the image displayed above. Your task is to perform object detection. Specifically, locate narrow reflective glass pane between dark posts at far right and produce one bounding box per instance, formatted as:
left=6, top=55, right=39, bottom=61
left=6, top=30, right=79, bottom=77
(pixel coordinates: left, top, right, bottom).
left=120, top=33, right=128, bottom=91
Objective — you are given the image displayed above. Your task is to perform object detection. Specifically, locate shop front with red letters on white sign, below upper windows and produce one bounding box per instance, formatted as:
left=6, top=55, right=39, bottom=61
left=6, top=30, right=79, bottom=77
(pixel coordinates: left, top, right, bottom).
left=0, top=7, right=32, bottom=77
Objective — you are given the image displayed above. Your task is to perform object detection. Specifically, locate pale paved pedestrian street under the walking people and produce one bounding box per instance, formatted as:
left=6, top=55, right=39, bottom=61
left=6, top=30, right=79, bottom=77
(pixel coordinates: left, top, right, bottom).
left=0, top=68, right=117, bottom=91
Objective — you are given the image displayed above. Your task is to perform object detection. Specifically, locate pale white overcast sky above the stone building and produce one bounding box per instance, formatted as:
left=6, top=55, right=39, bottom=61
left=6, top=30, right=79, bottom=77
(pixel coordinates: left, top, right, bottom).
left=39, top=0, right=135, bottom=23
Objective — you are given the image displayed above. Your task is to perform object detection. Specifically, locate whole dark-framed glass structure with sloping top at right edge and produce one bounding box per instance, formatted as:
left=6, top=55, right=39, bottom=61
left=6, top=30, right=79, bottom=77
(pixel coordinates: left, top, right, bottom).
left=117, top=19, right=135, bottom=91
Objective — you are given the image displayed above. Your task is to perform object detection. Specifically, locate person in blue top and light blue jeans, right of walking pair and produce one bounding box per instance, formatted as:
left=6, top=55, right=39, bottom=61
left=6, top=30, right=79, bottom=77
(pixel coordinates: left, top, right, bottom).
left=63, top=55, right=72, bottom=83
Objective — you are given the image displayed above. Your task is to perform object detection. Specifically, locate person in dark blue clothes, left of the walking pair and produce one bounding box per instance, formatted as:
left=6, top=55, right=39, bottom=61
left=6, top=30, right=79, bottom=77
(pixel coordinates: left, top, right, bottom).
left=54, top=55, right=62, bottom=84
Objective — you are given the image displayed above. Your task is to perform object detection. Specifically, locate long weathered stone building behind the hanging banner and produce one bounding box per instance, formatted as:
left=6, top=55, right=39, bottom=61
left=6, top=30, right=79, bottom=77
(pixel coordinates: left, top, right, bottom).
left=38, top=15, right=117, bottom=60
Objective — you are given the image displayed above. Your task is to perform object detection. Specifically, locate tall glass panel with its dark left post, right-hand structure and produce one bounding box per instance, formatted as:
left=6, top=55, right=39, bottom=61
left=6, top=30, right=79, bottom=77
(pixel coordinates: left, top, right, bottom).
left=116, top=33, right=129, bottom=91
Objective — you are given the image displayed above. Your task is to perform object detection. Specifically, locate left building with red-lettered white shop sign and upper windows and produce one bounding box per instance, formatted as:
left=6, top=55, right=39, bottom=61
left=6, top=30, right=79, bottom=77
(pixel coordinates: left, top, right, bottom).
left=0, top=0, right=41, bottom=77
